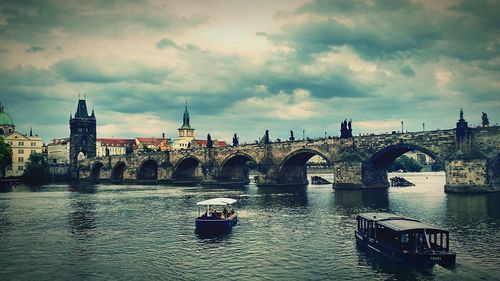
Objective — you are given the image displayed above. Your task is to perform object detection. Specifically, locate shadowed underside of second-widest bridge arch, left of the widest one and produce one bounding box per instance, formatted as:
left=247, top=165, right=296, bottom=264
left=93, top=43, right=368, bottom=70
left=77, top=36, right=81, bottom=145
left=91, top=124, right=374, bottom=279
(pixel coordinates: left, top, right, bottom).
left=277, top=148, right=332, bottom=185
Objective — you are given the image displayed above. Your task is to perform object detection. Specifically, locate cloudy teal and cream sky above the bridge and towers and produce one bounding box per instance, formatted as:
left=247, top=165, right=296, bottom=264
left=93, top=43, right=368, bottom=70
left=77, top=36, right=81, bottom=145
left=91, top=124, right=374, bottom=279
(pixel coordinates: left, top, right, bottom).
left=0, top=0, right=500, bottom=142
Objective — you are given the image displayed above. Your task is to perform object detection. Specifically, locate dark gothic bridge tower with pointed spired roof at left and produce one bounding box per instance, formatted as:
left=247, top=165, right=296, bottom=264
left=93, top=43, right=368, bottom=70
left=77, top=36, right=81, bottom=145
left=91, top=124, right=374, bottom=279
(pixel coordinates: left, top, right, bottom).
left=69, top=99, right=96, bottom=163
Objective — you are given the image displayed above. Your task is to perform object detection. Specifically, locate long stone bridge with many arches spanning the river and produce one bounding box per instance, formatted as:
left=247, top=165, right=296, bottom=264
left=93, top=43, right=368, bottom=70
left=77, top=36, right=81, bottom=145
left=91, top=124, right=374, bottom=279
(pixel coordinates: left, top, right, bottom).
left=77, top=126, right=500, bottom=192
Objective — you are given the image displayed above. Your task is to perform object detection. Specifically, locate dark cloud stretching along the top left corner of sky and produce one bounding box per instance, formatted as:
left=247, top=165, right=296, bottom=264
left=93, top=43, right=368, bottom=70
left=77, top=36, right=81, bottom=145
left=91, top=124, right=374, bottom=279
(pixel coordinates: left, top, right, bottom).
left=0, top=1, right=210, bottom=42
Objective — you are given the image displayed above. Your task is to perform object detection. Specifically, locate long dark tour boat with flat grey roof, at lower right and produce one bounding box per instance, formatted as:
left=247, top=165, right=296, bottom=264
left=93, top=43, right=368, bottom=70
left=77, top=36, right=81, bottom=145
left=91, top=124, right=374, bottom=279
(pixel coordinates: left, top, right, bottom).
left=355, top=213, right=456, bottom=267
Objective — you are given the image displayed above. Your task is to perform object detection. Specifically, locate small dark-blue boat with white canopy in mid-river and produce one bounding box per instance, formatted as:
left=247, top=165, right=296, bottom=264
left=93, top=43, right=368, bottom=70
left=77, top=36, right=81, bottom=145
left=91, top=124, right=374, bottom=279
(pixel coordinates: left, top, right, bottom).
left=195, top=198, right=238, bottom=234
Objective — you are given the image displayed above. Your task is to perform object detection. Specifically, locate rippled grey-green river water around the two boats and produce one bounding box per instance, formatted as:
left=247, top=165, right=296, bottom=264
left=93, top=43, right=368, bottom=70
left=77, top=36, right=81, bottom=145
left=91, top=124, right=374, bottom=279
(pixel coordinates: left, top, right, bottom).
left=0, top=173, right=500, bottom=280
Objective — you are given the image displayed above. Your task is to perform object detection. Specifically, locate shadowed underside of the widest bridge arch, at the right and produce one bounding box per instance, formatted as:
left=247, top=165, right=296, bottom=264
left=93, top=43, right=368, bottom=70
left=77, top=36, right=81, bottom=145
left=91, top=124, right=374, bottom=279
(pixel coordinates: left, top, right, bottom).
left=362, top=143, right=444, bottom=187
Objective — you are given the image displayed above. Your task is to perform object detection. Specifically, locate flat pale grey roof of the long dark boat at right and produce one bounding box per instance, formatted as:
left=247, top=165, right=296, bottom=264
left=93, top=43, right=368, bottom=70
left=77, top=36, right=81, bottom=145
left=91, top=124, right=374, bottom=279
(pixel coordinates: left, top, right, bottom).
left=358, top=213, right=448, bottom=232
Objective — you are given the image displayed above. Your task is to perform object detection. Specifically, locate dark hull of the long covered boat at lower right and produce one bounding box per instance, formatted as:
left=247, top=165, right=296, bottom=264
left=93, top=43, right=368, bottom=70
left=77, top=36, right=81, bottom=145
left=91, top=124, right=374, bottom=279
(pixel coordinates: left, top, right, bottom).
left=355, top=231, right=456, bottom=267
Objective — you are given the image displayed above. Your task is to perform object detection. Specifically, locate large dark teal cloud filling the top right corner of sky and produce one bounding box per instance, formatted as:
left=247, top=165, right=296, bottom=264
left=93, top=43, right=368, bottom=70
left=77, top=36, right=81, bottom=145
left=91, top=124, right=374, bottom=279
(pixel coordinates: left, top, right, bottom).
left=270, top=0, right=500, bottom=60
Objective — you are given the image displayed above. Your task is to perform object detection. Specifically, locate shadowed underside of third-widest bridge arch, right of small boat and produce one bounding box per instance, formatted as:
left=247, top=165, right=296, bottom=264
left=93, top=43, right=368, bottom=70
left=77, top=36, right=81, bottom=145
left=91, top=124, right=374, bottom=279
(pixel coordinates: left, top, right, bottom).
left=217, top=152, right=256, bottom=184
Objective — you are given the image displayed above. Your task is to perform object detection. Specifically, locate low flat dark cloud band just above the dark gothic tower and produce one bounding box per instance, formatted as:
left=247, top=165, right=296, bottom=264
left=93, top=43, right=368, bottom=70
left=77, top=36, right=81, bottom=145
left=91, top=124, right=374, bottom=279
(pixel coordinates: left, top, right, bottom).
left=52, top=57, right=171, bottom=84
